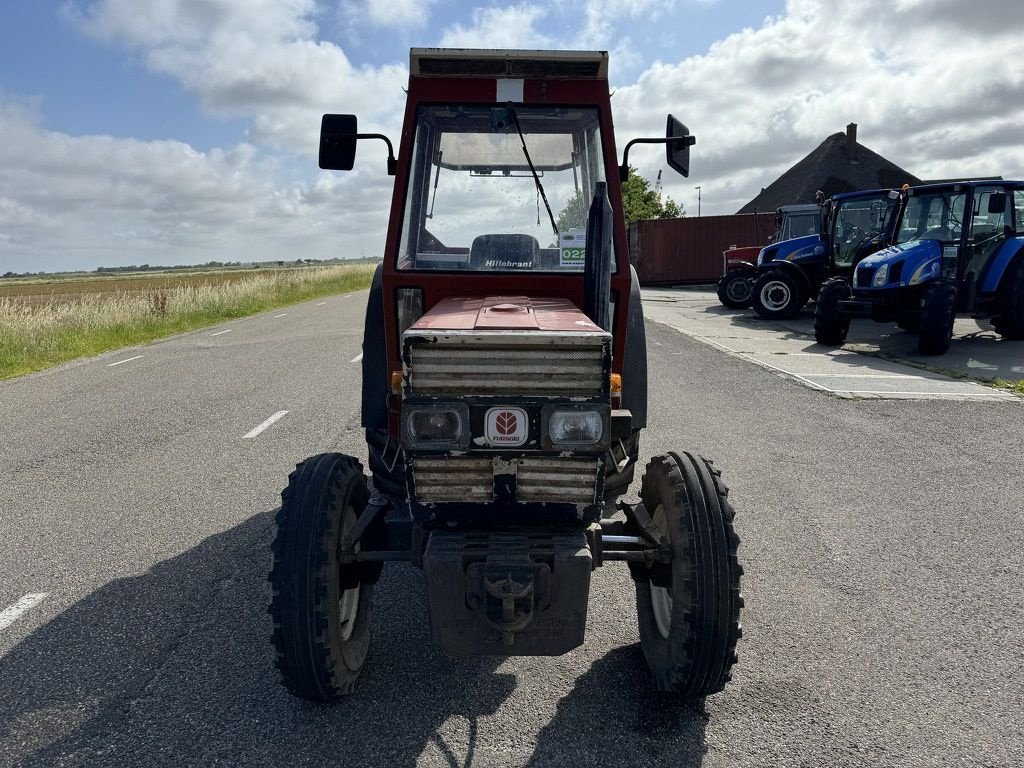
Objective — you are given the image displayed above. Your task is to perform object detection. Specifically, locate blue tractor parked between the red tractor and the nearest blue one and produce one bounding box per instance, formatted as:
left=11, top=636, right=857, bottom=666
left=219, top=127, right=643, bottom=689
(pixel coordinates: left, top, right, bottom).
left=753, top=189, right=900, bottom=319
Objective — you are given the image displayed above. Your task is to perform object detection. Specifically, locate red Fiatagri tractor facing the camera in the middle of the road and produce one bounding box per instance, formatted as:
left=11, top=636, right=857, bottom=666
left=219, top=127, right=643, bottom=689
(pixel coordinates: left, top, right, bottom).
left=270, top=49, right=742, bottom=700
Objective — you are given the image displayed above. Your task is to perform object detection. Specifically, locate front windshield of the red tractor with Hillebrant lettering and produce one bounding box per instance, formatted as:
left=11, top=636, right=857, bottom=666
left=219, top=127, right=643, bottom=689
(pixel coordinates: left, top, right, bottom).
left=397, top=105, right=605, bottom=271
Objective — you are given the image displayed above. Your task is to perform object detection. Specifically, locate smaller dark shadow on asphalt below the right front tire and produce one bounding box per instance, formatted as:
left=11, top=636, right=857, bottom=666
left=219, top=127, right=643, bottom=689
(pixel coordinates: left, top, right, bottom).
left=528, top=643, right=708, bottom=768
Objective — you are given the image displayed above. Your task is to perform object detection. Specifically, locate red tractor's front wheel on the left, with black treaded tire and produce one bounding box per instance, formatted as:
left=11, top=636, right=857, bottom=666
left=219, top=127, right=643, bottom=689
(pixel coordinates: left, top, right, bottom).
left=269, top=454, right=374, bottom=701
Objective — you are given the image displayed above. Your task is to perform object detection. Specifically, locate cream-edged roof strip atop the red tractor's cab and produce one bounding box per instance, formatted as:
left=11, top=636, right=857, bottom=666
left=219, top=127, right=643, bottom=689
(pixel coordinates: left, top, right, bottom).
left=409, top=48, right=608, bottom=80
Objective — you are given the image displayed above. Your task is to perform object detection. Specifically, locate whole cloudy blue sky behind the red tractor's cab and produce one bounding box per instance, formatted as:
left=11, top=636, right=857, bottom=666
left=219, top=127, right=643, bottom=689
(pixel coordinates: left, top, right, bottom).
left=0, top=0, right=1024, bottom=273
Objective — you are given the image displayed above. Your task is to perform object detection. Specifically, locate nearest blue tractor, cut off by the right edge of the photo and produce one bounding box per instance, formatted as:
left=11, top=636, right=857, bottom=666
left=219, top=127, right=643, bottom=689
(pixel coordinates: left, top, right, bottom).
left=814, top=180, right=1024, bottom=354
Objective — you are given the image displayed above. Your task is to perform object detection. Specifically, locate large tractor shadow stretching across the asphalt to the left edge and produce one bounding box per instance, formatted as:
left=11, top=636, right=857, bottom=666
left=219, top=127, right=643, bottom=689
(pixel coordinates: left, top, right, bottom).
left=0, top=509, right=512, bottom=766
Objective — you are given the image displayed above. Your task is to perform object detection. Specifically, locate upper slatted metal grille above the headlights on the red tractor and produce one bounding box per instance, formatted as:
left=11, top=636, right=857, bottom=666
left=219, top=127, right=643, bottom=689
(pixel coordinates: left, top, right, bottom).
left=408, top=336, right=605, bottom=397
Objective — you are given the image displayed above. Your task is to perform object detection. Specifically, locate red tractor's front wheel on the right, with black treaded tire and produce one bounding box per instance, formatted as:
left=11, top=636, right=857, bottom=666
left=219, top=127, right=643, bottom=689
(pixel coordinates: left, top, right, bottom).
left=631, top=453, right=743, bottom=699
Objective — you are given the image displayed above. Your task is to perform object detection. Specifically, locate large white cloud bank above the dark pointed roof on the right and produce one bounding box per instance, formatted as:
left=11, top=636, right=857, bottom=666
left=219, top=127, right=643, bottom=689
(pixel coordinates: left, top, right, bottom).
left=612, top=0, right=1024, bottom=213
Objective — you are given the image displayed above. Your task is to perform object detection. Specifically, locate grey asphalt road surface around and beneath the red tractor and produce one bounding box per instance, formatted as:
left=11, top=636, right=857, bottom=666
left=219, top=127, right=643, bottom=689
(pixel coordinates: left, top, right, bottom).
left=0, top=293, right=1024, bottom=766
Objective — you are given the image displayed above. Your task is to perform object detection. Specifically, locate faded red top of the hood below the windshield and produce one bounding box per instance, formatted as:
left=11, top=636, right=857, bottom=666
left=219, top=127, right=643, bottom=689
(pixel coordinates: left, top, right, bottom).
left=410, top=296, right=600, bottom=333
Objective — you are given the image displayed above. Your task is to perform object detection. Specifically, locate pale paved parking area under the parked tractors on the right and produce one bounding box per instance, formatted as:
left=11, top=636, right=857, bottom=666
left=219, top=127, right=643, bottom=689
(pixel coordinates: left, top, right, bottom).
left=643, top=288, right=1024, bottom=400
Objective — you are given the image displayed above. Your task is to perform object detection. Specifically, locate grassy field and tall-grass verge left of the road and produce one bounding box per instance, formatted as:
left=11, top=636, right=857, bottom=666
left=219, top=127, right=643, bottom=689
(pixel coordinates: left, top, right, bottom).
left=0, top=263, right=374, bottom=379
